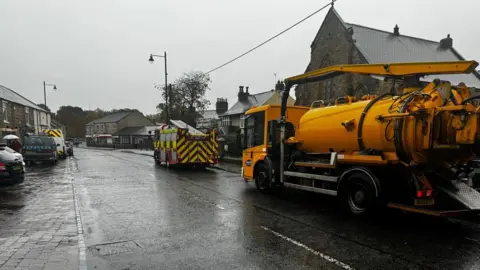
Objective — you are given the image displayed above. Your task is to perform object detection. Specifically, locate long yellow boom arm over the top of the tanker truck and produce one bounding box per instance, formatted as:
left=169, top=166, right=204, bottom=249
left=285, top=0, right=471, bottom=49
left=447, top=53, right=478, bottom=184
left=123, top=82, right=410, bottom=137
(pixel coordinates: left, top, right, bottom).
left=285, top=61, right=478, bottom=88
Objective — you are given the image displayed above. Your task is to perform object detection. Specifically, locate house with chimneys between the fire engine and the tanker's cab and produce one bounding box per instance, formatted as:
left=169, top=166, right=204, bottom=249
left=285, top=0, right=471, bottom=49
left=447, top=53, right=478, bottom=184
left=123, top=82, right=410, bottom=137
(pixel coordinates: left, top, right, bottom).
left=220, top=81, right=295, bottom=134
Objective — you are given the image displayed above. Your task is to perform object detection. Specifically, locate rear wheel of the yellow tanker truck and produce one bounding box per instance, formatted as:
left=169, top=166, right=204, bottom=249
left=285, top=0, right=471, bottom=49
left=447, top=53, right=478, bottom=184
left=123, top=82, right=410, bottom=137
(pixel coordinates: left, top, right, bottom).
left=340, top=172, right=378, bottom=215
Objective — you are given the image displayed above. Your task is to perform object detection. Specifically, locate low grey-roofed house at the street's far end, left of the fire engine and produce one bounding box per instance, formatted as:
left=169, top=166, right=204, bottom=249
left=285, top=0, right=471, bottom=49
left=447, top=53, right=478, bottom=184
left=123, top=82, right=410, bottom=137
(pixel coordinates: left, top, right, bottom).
left=85, top=110, right=154, bottom=140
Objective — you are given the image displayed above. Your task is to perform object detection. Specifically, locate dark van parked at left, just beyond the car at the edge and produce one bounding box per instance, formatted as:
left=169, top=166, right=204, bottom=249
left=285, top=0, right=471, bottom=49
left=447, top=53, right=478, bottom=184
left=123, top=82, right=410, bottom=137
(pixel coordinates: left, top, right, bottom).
left=23, top=135, right=58, bottom=164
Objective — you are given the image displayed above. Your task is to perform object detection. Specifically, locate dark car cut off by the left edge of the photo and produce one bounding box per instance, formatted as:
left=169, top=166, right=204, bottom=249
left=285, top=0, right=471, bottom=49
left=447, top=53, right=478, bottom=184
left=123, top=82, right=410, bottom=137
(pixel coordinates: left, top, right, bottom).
left=0, top=143, right=25, bottom=184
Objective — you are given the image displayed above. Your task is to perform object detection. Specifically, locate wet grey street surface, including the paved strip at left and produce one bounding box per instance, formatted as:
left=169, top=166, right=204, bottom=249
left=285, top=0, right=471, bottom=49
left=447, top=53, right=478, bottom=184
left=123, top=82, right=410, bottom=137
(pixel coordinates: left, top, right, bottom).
left=0, top=148, right=480, bottom=269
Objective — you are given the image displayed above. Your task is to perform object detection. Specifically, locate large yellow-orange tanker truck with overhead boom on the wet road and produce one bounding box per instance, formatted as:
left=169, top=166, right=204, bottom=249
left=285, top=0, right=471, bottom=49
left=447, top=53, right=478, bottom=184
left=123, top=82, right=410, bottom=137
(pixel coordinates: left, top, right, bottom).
left=242, top=61, right=480, bottom=216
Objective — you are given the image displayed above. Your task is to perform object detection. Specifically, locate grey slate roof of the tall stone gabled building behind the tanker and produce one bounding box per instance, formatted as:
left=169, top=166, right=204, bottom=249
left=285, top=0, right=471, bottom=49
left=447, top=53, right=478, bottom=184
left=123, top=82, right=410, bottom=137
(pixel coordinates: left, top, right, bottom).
left=346, top=23, right=480, bottom=88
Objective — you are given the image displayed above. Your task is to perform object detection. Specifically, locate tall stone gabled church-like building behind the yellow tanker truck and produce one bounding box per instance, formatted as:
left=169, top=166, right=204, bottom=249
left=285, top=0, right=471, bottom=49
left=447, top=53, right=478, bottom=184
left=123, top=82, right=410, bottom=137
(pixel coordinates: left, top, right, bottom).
left=295, top=7, right=480, bottom=106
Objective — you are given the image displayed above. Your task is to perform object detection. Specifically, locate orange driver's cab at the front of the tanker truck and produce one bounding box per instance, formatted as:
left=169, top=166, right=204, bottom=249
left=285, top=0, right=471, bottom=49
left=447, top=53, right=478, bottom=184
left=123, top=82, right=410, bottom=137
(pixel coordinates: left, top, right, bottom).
left=242, top=105, right=309, bottom=190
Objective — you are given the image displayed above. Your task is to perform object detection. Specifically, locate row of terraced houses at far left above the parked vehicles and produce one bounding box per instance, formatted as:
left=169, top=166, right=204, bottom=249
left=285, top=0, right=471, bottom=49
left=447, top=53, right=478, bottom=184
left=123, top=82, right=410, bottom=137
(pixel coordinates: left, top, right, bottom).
left=0, top=85, right=51, bottom=134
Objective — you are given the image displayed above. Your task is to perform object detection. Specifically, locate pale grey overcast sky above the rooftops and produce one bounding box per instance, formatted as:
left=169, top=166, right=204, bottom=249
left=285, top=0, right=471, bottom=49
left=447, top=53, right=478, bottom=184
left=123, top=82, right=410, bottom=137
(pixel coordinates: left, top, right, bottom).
left=0, top=0, right=480, bottom=113
